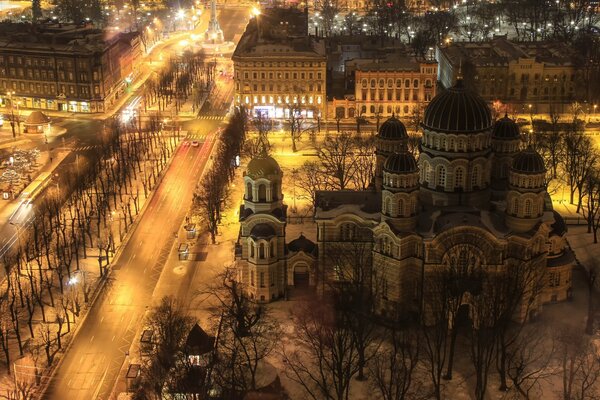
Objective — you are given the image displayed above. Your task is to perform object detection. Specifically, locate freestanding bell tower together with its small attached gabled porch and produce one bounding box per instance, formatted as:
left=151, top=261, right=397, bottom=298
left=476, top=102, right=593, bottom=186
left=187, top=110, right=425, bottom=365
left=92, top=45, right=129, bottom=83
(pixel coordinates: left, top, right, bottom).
left=235, top=155, right=316, bottom=302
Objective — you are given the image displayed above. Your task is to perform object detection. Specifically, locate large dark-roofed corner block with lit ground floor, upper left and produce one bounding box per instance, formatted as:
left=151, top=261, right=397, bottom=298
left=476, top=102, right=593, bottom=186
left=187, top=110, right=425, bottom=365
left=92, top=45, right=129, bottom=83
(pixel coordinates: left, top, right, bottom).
left=0, top=23, right=142, bottom=113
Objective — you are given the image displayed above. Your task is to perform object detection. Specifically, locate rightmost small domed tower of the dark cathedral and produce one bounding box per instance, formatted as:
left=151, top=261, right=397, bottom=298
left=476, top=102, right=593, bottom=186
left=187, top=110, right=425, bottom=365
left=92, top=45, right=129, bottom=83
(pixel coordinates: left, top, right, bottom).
left=506, top=147, right=546, bottom=232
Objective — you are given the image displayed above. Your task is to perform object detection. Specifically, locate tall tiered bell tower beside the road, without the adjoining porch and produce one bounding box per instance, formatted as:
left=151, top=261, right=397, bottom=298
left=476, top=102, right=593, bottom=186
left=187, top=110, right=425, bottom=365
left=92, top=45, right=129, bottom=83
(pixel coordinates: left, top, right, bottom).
left=236, top=154, right=287, bottom=302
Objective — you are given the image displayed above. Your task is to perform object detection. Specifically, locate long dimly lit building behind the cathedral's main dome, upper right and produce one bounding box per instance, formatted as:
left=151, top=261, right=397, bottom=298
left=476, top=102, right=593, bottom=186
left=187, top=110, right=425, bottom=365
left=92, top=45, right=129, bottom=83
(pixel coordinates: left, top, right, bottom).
left=436, top=37, right=587, bottom=113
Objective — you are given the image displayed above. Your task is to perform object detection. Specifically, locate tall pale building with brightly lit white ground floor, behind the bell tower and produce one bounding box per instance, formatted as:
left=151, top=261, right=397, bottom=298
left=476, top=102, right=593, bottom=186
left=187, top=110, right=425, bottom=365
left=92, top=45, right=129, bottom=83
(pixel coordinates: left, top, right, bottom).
left=232, top=8, right=326, bottom=120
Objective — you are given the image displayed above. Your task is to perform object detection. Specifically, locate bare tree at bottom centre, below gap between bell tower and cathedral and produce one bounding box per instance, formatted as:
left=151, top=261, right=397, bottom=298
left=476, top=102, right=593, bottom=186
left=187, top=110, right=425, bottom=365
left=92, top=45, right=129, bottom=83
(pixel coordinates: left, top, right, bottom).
left=282, top=299, right=359, bottom=400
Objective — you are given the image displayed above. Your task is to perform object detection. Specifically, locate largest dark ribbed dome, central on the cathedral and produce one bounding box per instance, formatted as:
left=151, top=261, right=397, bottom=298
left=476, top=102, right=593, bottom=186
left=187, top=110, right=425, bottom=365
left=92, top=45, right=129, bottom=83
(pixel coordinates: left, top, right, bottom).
left=423, top=79, right=492, bottom=133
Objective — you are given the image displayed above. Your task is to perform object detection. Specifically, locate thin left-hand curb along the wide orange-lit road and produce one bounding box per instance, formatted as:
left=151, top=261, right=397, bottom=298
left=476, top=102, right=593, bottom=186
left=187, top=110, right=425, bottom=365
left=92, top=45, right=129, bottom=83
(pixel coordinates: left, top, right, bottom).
left=37, top=138, right=181, bottom=399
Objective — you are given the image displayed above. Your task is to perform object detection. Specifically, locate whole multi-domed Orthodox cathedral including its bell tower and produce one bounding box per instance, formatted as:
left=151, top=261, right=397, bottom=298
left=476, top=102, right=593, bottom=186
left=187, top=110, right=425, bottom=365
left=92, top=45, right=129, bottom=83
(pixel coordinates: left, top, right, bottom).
left=236, top=79, right=574, bottom=318
